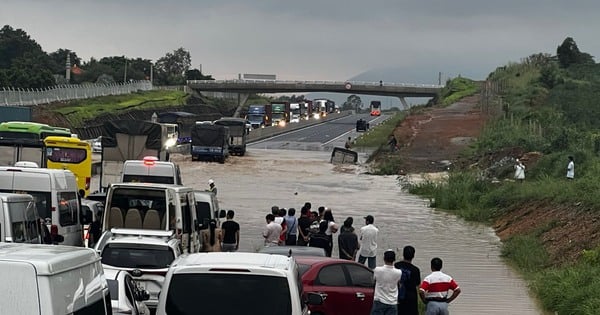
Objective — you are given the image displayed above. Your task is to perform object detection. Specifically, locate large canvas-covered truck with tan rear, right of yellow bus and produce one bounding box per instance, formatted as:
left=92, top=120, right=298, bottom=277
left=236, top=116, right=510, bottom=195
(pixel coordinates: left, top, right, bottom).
left=100, top=120, right=170, bottom=192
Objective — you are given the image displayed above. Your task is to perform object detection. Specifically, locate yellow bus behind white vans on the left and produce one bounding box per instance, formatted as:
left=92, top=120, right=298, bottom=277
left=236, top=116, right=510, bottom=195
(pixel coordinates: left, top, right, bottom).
left=44, top=136, right=92, bottom=197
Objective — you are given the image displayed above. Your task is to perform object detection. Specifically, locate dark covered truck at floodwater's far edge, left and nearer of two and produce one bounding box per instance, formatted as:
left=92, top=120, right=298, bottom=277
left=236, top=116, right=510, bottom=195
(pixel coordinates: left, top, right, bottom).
left=190, top=124, right=230, bottom=163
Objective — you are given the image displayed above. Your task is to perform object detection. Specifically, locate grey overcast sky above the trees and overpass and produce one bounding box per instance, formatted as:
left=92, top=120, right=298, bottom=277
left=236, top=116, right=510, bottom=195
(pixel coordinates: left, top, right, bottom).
left=0, top=0, right=600, bottom=83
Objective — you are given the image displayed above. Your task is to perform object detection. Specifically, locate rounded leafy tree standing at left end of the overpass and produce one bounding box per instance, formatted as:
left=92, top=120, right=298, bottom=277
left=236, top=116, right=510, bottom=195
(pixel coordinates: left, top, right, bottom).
left=155, top=47, right=192, bottom=85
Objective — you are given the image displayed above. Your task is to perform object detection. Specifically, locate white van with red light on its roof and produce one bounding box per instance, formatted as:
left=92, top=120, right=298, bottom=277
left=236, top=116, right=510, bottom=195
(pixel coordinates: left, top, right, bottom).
left=121, top=156, right=182, bottom=185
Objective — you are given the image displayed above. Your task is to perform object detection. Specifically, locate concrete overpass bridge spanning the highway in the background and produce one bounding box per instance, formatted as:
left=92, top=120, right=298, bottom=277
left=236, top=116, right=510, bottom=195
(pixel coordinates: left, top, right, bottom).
left=187, top=79, right=443, bottom=114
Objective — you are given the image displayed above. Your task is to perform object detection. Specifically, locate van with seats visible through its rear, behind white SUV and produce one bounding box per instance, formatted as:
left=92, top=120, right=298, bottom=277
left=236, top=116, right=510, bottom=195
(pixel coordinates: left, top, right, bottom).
left=97, top=183, right=200, bottom=253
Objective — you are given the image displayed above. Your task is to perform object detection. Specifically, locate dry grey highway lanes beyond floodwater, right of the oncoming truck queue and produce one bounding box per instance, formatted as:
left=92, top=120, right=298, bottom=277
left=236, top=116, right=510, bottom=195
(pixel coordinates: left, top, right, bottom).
left=249, top=114, right=387, bottom=151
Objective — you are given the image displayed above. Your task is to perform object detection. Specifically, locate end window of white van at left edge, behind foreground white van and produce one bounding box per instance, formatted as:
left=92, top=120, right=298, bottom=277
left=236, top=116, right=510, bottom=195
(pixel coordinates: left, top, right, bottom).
left=8, top=202, right=40, bottom=243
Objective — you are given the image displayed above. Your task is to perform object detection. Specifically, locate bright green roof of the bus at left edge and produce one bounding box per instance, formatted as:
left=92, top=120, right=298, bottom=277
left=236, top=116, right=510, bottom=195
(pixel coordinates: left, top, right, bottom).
left=0, top=121, right=71, bottom=140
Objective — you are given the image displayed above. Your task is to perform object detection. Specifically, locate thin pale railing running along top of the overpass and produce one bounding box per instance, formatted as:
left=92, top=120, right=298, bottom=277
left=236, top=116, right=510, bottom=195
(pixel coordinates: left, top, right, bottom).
left=187, top=79, right=444, bottom=88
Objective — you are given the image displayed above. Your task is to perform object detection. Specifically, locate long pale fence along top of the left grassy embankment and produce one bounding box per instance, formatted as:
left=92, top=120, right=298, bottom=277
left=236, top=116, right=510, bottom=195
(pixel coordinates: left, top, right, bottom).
left=0, top=81, right=152, bottom=106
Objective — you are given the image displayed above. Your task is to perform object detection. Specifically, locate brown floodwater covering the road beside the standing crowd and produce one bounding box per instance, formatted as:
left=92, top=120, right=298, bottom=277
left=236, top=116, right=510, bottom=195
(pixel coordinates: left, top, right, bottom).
left=173, top=148, right=542, bottom=315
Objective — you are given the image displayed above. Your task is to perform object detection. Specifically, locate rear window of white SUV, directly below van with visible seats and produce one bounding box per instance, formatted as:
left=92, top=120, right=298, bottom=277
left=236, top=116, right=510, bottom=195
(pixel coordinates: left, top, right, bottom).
left=102, top=243, right=175, bottom=269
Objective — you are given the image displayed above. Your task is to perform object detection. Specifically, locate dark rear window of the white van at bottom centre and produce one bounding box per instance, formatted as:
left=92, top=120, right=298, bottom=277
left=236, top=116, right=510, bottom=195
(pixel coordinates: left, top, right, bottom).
left=165, top=273, right=292, bottom=315
